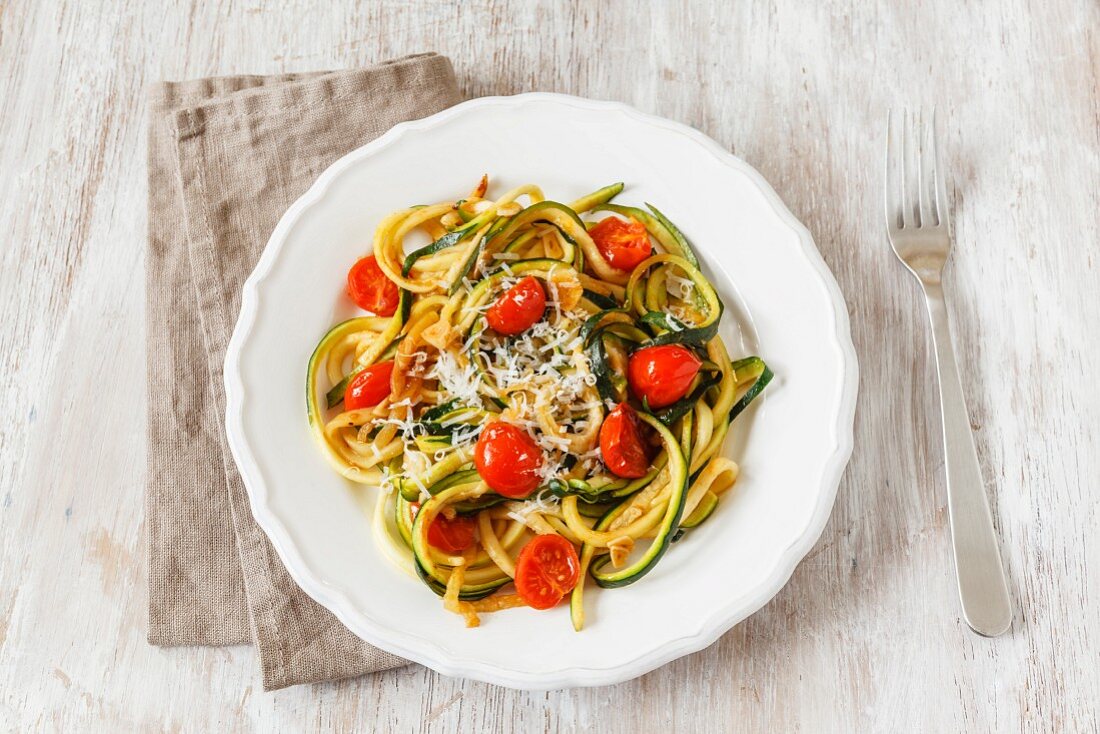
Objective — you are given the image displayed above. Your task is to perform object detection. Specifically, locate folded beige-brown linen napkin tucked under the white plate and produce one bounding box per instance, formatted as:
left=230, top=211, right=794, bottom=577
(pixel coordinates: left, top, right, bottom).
left=145, top=54, right=460, bottom=689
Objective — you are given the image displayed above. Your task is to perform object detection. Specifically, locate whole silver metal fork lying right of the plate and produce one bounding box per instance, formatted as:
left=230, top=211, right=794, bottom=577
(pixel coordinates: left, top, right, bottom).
left=886, top=112, right=1012, bottom=637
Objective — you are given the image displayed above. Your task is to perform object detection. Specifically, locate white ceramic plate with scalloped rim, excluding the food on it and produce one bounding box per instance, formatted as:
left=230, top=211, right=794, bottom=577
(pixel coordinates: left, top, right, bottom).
left=226, top=94, right=857, bottom=689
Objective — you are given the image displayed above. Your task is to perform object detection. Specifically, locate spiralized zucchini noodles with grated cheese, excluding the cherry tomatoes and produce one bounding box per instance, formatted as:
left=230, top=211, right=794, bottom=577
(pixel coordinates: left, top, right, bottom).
left=306, top=177, right=772, bottom=631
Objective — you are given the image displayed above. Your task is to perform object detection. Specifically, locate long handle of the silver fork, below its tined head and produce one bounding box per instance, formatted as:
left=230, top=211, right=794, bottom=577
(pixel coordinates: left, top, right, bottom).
left=924, top=283, right=1012, bottom=637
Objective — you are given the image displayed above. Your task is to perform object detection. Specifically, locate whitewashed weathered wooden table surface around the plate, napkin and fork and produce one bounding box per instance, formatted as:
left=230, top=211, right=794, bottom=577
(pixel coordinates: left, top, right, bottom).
left=0, top=0, right=1100, bottom=732
